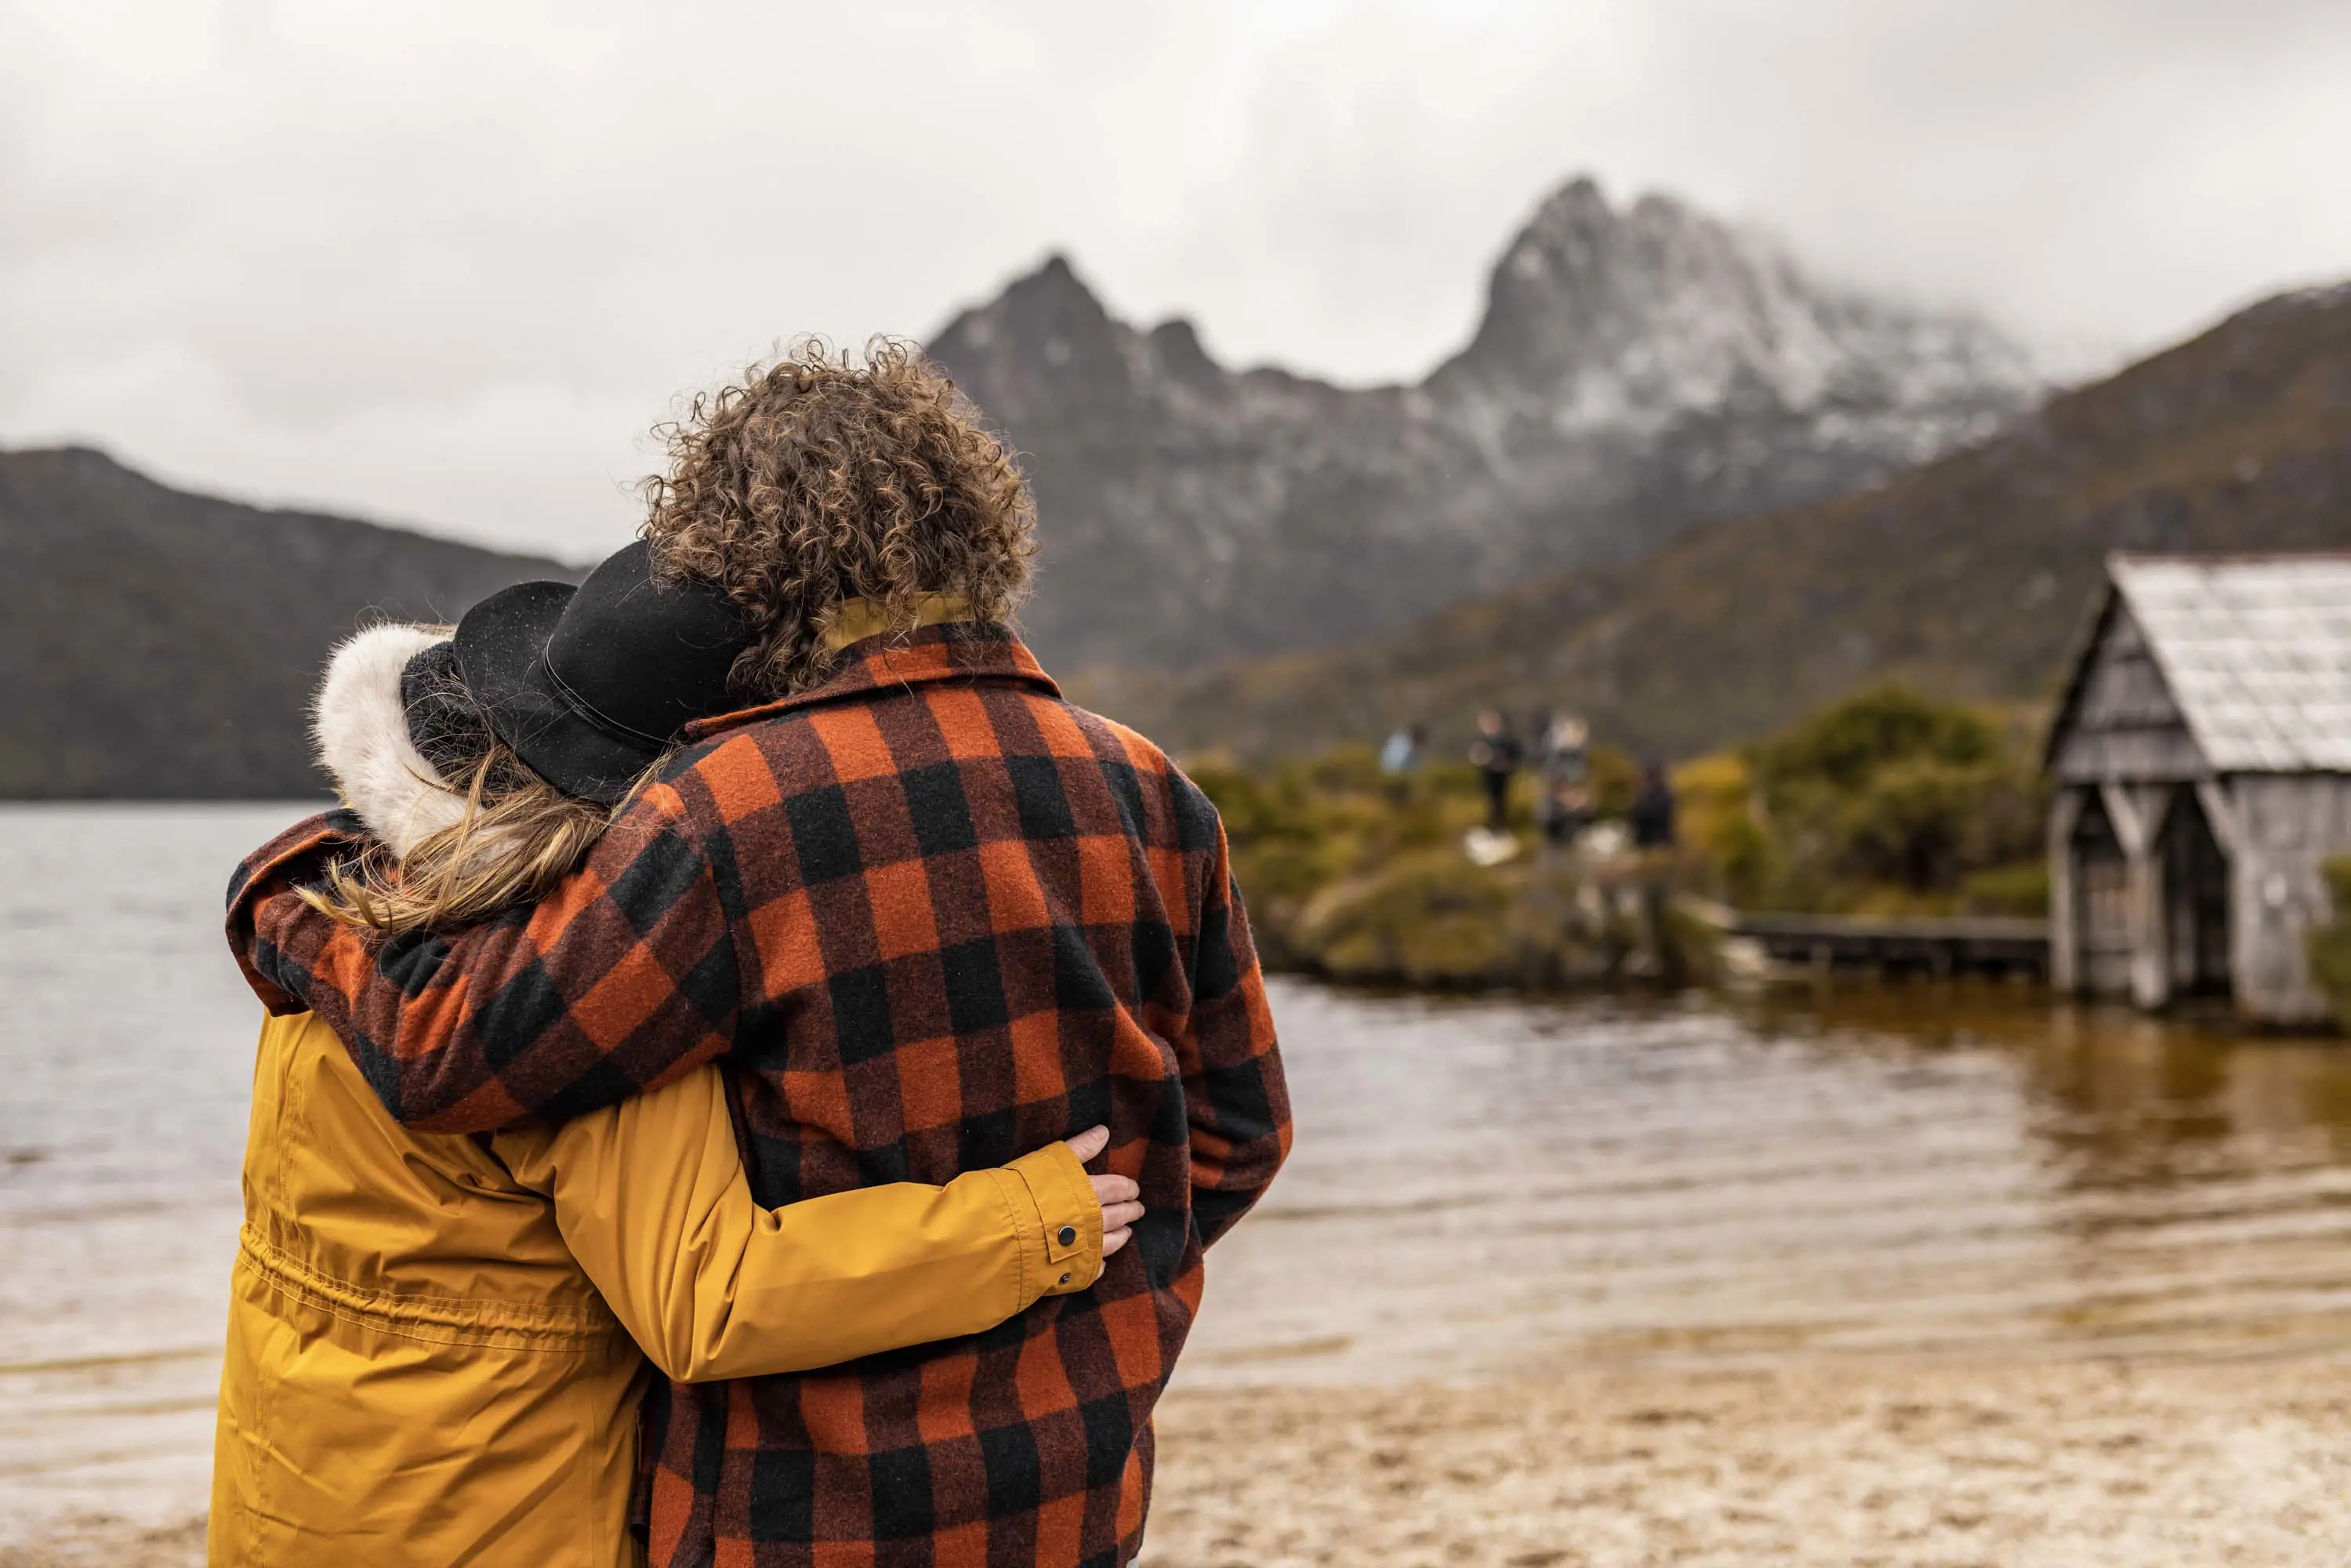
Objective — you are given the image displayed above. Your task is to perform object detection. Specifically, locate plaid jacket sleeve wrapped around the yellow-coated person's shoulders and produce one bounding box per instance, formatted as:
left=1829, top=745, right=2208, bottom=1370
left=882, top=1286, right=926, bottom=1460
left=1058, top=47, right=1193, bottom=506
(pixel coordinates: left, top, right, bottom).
left=228, top=804, right=741, bottom=1133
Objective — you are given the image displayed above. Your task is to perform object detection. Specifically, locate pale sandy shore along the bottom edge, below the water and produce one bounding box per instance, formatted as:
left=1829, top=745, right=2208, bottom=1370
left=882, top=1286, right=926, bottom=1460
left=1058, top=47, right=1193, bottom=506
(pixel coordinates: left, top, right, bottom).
left=27, top=1359, right=2351, bottom=1568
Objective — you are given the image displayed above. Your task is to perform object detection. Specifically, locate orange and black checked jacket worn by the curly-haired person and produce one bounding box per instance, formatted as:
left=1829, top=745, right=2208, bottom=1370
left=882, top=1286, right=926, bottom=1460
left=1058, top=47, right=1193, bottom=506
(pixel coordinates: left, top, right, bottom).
left=228, top=623, right=1290, bottom=1568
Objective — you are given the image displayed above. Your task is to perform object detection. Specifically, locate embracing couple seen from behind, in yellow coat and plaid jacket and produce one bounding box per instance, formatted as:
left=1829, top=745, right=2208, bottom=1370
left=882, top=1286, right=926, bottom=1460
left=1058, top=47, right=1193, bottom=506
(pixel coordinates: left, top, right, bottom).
left=212, top=346, right=1290, bottom=1568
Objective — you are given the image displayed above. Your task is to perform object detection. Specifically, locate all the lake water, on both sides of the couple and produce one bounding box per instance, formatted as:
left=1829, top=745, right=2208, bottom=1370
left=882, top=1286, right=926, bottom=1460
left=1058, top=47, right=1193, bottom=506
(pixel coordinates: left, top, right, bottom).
left=0, top=806, right=2351, bottom=1542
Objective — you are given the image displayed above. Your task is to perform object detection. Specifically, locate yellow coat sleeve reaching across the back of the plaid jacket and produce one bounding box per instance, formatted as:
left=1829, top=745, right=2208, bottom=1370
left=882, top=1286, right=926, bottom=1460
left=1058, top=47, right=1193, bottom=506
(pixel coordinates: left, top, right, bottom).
left=496, top=1067, right=1103, bottom=1382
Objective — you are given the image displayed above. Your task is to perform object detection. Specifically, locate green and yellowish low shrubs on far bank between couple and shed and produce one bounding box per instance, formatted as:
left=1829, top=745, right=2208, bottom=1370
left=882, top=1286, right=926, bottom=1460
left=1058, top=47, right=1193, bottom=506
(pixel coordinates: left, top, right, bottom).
left=1192, top=687, right=2048, bottom=989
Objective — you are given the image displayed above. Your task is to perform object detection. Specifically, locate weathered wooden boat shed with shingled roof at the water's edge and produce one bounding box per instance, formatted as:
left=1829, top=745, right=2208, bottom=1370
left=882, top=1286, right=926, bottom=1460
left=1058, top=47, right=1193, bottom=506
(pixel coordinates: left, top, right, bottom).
left=2048, top=555, right=2351, bottom=1025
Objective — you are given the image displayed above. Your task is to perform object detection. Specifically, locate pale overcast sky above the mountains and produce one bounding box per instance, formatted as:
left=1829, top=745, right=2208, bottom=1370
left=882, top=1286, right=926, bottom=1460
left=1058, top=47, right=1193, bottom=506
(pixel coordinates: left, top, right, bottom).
left=0, top=0, right=2351, bottom=560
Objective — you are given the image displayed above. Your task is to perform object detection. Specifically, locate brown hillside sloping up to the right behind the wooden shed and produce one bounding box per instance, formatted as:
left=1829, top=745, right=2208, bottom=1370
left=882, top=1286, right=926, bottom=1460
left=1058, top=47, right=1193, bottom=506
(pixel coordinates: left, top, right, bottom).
left=1077, top=285, right=2351, bottom=771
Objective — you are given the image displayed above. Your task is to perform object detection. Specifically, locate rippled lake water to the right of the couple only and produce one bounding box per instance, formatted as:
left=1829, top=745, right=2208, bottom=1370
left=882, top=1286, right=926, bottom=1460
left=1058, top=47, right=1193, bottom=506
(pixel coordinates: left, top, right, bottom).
left=1194, top=985, right=2351, bottom=1380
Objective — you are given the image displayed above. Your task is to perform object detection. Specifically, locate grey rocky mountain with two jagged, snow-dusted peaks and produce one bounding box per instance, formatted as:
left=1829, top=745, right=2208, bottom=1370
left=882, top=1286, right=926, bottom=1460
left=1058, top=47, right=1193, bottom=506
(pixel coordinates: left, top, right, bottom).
left=931, top=179, right=2041, bottom=670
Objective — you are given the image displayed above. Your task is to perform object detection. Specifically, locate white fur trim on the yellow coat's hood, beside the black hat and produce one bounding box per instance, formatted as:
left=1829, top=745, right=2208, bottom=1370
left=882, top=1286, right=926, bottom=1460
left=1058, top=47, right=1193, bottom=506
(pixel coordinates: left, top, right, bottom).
left=310, top=623, right=466, bottom=858
